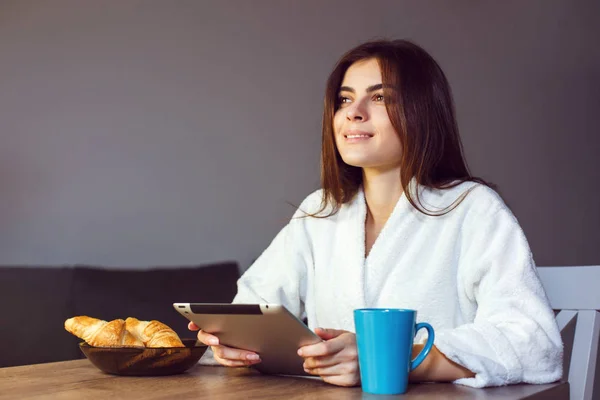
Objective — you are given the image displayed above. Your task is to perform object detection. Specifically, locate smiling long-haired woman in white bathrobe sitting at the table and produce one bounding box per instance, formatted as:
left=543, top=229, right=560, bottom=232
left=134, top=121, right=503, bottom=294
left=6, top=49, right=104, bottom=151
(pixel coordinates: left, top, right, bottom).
left=190, top=40, right=562, bottom=387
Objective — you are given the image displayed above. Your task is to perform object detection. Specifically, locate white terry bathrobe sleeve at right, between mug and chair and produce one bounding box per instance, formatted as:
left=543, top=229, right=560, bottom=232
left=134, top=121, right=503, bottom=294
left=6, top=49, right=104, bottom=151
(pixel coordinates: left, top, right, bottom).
left=435, top=194, right=563, bottom=387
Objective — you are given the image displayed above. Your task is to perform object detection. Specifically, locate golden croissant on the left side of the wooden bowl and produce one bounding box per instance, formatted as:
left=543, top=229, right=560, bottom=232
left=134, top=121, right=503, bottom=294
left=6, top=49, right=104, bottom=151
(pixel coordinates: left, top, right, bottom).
left=65, top=316, right=144, bottom=347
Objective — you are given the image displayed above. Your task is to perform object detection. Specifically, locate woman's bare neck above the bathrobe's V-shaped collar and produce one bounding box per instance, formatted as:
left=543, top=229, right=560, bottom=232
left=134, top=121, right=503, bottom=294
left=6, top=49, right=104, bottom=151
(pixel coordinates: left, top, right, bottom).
left=363, top=168, right=403, bottom=226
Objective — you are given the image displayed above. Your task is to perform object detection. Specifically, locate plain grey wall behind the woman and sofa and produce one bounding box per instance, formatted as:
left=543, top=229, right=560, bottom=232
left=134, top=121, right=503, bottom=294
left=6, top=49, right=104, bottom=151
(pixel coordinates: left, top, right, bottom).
left=0, top=0, right=600, bottom=268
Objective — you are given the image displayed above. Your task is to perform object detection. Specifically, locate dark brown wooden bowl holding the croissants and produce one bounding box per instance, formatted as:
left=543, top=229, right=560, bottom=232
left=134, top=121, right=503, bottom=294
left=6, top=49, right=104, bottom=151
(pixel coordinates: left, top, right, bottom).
left=79, top=339, right=208, bottom=376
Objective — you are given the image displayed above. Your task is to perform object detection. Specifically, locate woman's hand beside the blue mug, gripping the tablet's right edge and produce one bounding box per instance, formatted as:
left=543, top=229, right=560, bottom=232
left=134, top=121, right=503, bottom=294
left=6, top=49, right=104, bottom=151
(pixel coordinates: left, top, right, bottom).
left=298, top=328, right=360, bottom=386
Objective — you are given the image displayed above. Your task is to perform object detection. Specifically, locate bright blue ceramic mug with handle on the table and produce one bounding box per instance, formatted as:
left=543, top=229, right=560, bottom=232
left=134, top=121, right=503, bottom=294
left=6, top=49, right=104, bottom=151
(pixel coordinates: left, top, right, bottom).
left=354, top=308, right=435, bottom=394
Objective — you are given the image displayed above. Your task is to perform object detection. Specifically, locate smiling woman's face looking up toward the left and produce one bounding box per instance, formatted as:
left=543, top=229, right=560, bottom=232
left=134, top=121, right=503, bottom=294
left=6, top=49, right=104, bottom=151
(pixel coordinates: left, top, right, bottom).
left=333, top=59, right=401, bottom=170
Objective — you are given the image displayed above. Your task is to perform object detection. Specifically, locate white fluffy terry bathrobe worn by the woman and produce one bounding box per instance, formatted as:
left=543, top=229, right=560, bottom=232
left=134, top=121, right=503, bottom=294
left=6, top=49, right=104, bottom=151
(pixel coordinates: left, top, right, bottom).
left=234, top=181, right=562, bottom=387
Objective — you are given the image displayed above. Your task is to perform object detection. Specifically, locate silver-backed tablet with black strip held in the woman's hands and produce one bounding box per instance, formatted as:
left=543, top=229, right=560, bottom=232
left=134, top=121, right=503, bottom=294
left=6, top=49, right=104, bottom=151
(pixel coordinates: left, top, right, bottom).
left=173, top=303, right=322, bottom=375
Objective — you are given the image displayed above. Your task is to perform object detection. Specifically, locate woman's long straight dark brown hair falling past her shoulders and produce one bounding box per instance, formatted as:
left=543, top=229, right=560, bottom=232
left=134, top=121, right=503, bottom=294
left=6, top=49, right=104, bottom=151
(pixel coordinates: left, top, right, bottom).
left=309, top=40, right=493, bottom=217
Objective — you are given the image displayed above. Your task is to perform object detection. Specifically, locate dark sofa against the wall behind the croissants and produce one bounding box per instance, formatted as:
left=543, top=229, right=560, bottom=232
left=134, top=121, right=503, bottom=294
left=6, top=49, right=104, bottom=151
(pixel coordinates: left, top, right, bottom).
left=0, top=262, right=240, bottom=367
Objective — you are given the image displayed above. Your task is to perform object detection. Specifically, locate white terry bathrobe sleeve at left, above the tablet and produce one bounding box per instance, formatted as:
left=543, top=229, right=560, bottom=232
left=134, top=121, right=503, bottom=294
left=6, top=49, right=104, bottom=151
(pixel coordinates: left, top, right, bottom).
left=233, top=193, right=320, bottom=319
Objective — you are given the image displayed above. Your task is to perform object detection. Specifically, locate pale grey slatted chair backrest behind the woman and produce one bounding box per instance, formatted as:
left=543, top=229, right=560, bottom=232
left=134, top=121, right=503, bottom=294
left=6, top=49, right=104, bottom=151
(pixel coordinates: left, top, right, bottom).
left=538, top=265, right=600, bottom=400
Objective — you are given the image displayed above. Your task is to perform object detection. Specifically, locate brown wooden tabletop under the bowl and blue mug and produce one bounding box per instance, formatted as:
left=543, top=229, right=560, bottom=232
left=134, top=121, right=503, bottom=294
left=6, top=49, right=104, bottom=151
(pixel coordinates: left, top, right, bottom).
left=0, top=360, right=569, bottom=400
